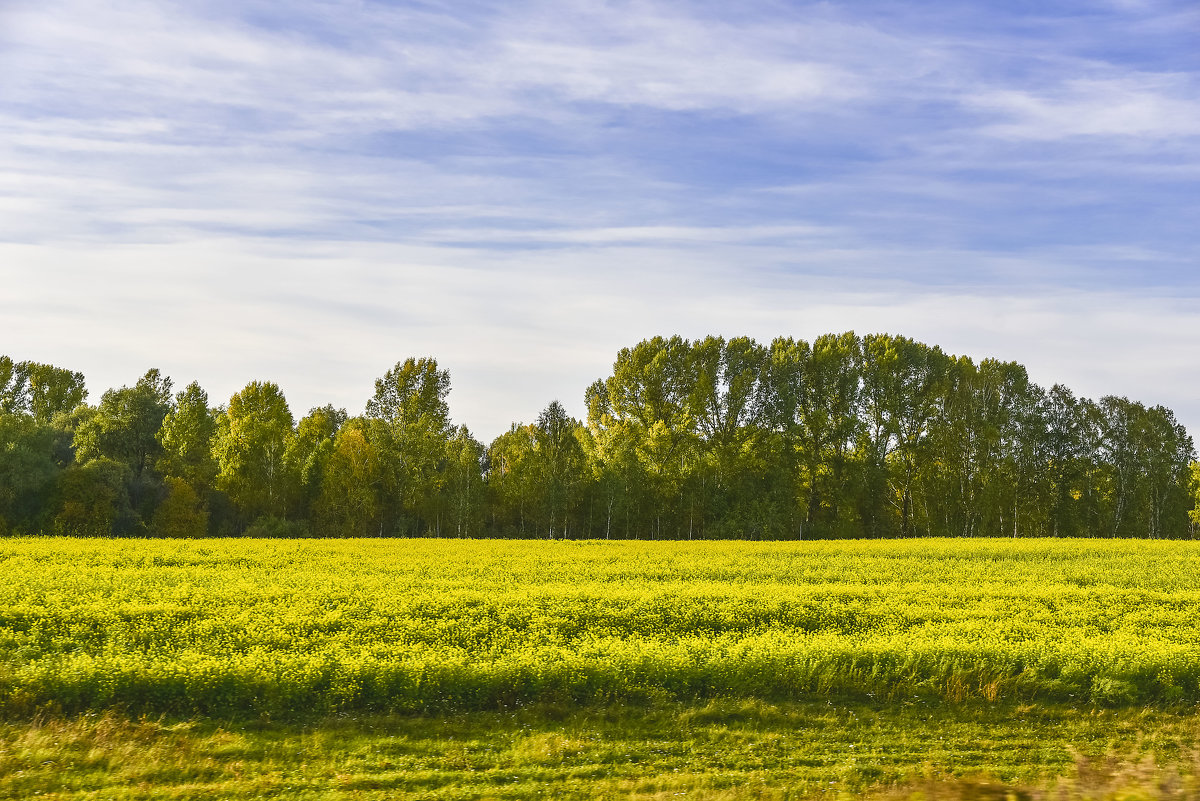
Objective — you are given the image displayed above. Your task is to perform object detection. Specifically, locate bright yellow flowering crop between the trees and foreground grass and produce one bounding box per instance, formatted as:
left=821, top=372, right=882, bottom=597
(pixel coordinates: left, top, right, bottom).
left=0, top=538, right=1200, bottom=718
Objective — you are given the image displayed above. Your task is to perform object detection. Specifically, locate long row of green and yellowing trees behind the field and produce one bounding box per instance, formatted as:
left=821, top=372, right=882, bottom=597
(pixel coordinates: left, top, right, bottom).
left=0, top=333, right=1200, bottom=540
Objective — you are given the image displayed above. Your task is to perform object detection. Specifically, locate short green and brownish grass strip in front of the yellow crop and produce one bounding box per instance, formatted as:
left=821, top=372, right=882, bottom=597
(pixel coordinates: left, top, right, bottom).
left=7, top=699, right=1200, bottom=801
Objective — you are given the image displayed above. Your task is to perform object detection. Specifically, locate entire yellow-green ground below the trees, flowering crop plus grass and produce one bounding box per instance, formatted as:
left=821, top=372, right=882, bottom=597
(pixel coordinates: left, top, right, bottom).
left=0, top=538, right=1200, bottom=799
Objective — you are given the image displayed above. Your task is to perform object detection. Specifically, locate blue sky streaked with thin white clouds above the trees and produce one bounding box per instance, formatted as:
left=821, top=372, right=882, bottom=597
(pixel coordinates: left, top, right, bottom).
left=0, top=0, right=1200, bottom=442
